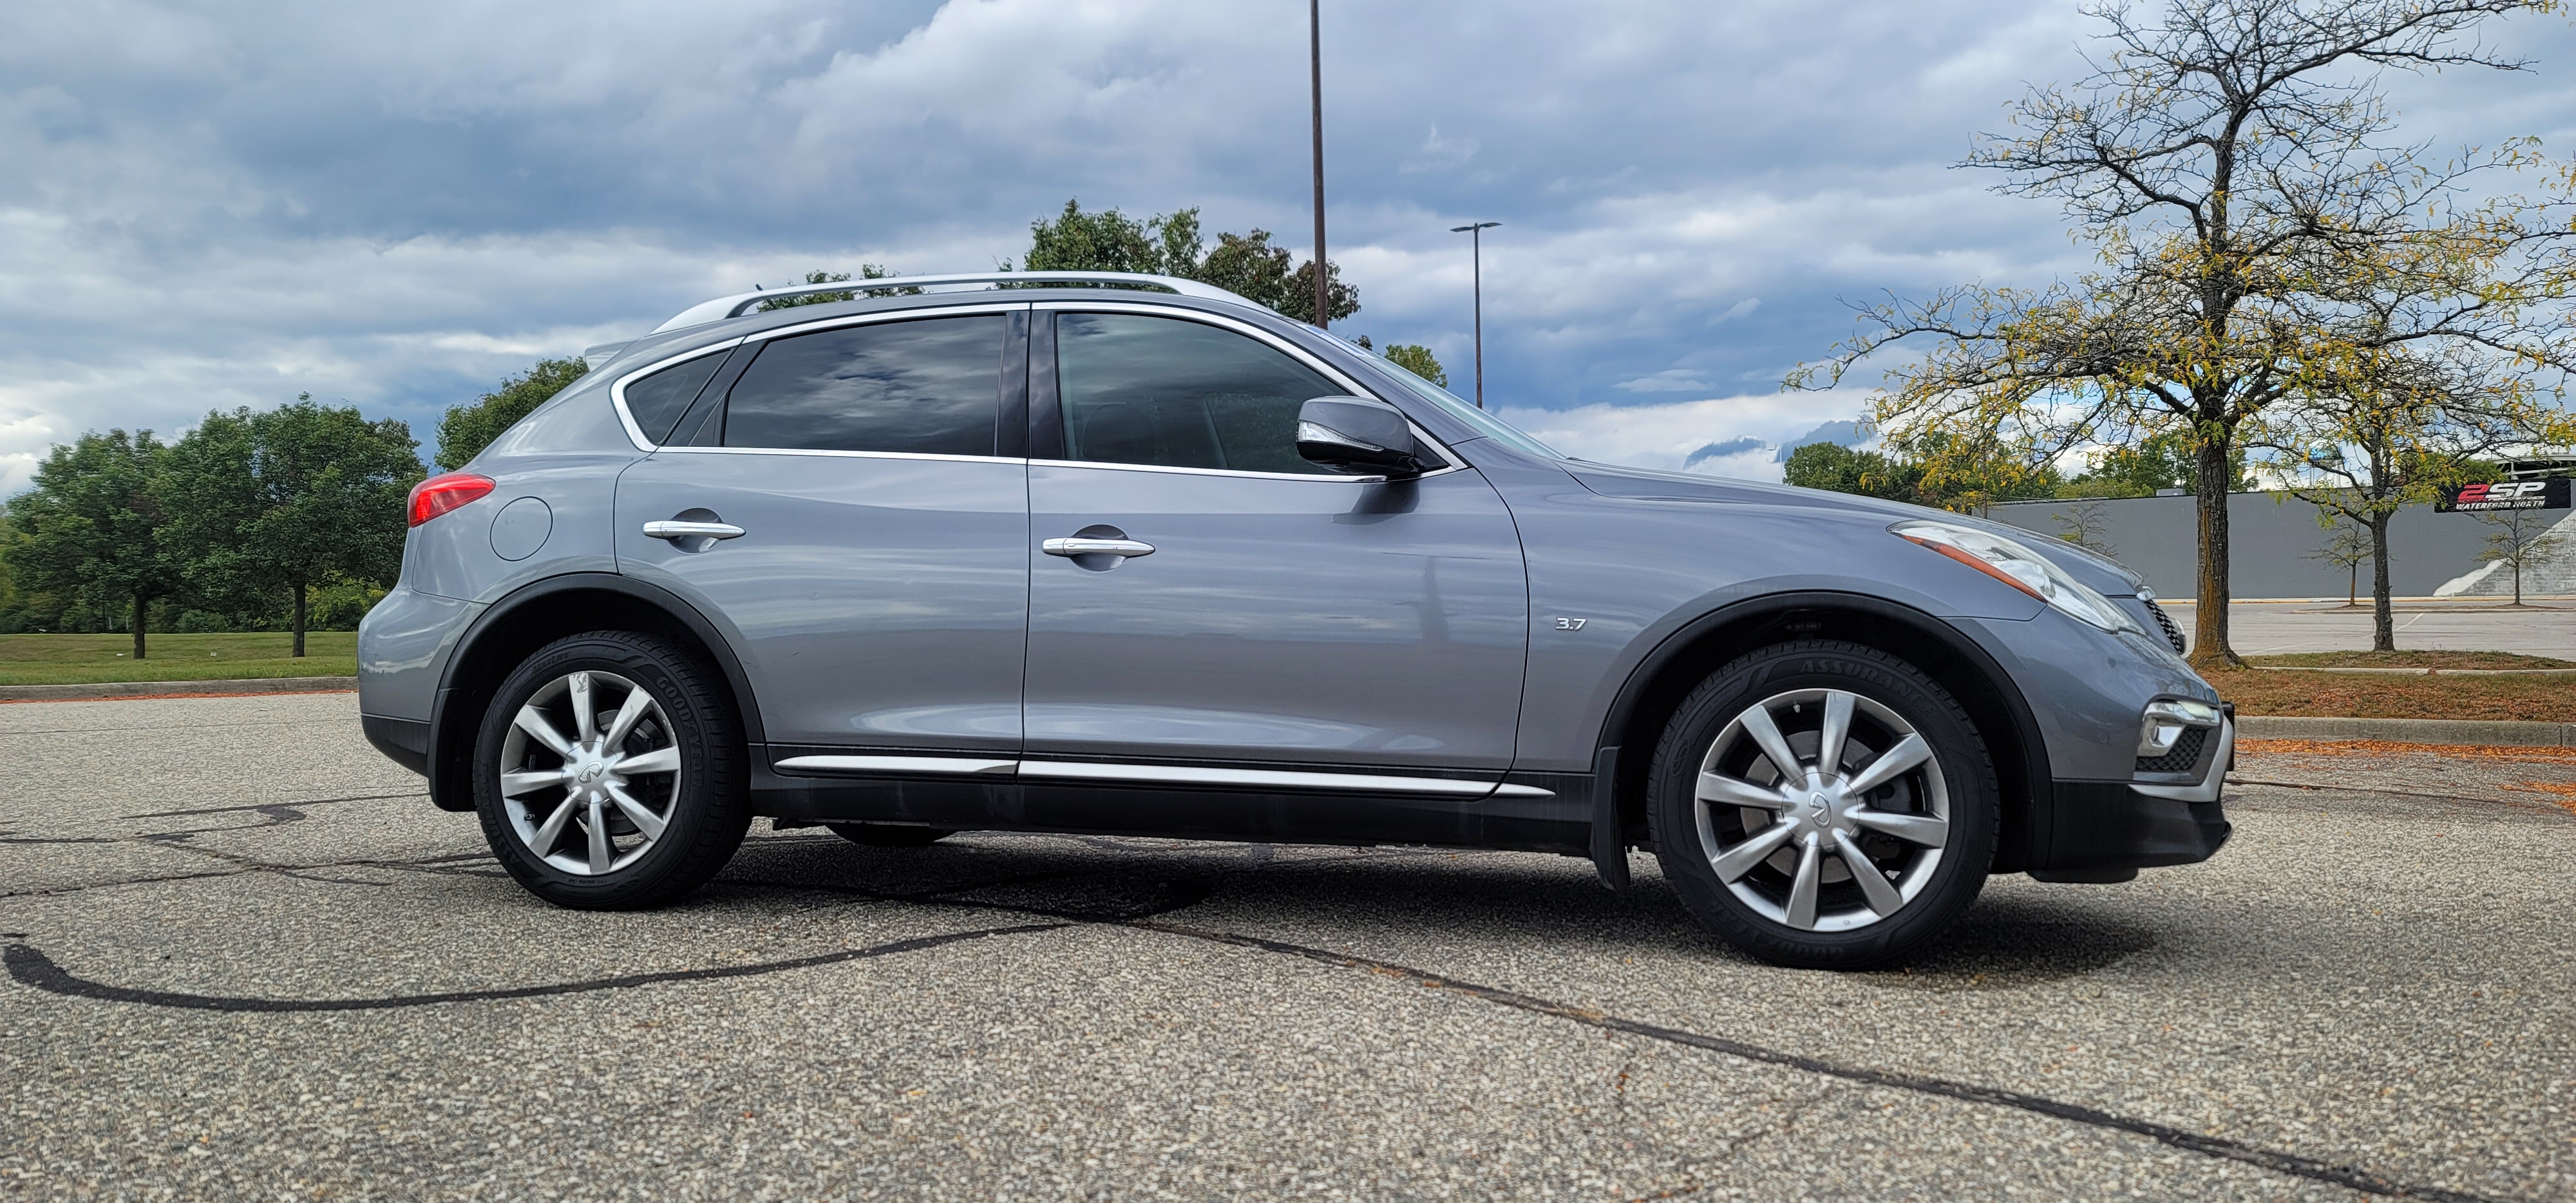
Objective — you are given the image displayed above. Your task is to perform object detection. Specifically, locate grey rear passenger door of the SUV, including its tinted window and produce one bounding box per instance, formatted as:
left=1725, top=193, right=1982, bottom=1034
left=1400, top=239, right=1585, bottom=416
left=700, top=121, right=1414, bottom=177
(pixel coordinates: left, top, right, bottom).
left=618, top=304, right=1028, bottom=755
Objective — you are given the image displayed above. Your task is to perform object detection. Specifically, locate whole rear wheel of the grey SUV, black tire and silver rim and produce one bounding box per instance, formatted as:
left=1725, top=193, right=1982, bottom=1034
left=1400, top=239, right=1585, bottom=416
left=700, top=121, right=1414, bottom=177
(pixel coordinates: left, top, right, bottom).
left=474, top=631, right=752, bottom=909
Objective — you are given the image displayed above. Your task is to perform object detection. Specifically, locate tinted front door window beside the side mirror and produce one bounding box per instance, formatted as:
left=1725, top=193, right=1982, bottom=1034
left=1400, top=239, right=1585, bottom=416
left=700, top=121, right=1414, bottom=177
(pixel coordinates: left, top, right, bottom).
left=1056, top=314, right=1345, bottom=477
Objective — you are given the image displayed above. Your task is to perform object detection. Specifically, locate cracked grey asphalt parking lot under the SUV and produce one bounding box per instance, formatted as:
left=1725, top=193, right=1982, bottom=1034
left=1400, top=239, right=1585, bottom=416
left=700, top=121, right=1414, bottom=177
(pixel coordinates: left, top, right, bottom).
left=0, top=696, right=2576, bottom=1200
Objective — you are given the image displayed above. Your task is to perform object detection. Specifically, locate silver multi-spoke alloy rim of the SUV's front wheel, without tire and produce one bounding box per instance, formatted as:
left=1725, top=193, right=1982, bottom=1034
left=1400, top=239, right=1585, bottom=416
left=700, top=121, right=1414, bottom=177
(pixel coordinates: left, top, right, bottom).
left=1692, top=690, right=1950, bottom=933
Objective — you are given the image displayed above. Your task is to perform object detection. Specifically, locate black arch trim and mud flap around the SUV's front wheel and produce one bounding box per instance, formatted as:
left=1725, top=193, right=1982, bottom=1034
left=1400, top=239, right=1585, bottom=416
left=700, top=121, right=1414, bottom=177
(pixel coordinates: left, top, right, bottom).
left=1592, top=590, right=2056, bottom=876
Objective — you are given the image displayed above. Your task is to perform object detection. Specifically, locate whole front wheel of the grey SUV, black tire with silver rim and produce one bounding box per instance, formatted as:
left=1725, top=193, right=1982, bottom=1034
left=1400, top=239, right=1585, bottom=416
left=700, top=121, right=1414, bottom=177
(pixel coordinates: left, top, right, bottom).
left=1646, top=641, right=1999, bottom=969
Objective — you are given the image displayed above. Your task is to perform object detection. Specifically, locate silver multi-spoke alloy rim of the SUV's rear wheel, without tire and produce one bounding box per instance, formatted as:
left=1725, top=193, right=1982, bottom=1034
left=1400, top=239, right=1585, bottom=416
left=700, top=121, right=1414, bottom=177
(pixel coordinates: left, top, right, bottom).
left=500, top=672, right=680, bottom=876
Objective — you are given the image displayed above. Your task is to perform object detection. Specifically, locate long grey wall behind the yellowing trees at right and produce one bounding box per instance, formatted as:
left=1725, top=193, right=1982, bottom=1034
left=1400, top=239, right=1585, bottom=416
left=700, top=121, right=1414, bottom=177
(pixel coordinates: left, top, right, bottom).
left=1986, top=492, right=2504, bottom=598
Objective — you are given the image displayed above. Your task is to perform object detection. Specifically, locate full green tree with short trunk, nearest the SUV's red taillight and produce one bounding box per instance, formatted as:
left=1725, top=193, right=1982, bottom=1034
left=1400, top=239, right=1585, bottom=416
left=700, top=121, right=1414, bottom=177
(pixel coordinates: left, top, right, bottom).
left=167, top=394, right=420, bottom=657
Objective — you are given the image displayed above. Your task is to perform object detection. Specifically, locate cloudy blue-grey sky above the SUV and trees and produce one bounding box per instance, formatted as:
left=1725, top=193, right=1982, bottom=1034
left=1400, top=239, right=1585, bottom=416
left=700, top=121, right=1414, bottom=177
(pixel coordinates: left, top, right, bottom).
left=0, top=0, right=2576, bottom=495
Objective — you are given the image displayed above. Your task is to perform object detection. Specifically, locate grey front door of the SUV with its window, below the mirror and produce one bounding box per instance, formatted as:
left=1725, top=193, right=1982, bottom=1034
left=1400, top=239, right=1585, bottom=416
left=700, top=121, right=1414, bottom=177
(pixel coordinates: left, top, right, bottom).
left=1020, top=304, right=1528, bottom=783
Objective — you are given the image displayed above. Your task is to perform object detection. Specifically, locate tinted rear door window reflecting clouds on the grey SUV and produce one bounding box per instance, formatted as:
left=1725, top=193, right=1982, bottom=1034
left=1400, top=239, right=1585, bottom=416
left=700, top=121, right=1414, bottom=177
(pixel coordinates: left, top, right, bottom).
left=724, top=314, right=1002, bottom=456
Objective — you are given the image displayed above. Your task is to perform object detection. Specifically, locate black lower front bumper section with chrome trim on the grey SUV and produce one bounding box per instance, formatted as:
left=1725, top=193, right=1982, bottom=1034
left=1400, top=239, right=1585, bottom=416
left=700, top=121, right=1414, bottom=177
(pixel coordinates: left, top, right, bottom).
left=2027, top=719, right=2236, bottom=881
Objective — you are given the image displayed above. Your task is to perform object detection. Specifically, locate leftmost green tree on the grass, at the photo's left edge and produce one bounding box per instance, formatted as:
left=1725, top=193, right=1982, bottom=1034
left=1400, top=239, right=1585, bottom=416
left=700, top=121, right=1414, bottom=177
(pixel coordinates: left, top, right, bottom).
left=8, top=430, right=180, bottom=659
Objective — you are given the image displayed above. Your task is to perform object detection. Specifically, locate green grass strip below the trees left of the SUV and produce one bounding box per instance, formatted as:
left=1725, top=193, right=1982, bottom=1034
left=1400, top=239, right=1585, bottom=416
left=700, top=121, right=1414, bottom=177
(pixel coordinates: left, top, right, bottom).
left=0, top=631, right=358, bottom=685
